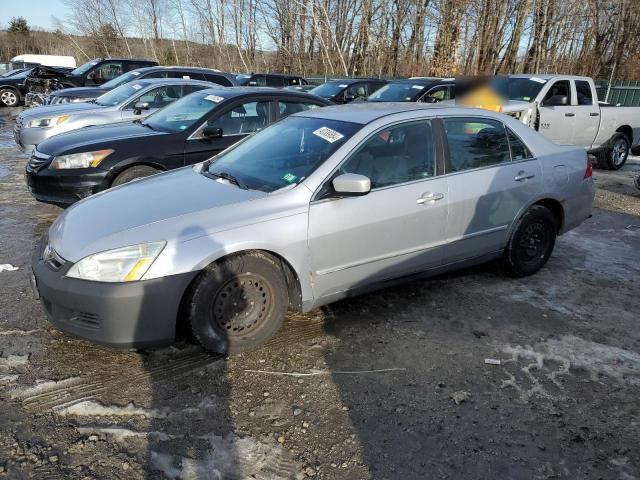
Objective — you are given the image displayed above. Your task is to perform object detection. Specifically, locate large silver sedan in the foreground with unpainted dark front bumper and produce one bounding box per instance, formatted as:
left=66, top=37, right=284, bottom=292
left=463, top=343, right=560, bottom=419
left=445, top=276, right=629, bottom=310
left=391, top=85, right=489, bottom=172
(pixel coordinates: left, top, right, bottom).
left=33, top=103, right=594, bottom=353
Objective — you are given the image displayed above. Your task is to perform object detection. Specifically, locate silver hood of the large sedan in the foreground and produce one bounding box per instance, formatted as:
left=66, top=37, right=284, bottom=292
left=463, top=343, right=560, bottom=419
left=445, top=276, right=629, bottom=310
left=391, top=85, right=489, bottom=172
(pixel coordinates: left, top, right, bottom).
left=49, top=166, right=268, bottom=262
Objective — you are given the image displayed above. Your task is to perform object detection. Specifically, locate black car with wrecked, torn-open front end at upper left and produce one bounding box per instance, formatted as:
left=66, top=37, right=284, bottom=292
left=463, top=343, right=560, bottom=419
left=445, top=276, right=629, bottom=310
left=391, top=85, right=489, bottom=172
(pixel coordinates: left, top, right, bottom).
left=25, top=58, right=158, bottom=105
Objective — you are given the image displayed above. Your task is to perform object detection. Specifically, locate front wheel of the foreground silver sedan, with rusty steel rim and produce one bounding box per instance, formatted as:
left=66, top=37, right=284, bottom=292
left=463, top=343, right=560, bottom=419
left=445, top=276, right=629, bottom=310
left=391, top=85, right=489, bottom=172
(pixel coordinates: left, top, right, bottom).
left=187, top=252, right=289, bottom=354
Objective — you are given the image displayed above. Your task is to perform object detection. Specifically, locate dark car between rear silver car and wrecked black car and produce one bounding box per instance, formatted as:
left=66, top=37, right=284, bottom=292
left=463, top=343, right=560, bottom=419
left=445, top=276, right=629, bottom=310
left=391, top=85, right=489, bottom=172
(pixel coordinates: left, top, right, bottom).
left=44, top=67, right=237, bottom=105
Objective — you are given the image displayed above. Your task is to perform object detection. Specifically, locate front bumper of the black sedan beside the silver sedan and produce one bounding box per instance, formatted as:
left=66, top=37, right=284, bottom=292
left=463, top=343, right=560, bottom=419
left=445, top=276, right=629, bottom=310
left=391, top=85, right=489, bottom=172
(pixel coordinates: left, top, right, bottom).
left=25, top=160, right=109, bottom=207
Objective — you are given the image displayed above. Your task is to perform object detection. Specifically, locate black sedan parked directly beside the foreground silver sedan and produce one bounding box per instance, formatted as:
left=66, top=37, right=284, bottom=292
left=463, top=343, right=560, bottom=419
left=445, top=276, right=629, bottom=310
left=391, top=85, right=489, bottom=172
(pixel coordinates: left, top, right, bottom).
left=26, top=87, right=331, bottom=206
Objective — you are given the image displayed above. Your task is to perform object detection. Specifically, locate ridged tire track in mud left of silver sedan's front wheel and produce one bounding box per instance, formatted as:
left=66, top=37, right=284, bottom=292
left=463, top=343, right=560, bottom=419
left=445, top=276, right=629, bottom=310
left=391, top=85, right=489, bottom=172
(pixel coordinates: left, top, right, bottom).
left=13, top=352, right=222, bottom=412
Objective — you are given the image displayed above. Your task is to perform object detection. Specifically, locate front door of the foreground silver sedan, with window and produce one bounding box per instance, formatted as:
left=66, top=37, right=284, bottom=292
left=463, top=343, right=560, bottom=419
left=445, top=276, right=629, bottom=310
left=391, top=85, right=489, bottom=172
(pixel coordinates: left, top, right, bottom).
left=308, top=120, right=448, bottom=299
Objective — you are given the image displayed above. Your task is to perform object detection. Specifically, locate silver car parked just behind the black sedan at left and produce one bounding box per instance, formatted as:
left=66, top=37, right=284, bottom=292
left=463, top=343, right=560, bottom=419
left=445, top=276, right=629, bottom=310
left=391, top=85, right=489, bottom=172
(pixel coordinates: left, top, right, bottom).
left=13, top=78, right=213, bottom=152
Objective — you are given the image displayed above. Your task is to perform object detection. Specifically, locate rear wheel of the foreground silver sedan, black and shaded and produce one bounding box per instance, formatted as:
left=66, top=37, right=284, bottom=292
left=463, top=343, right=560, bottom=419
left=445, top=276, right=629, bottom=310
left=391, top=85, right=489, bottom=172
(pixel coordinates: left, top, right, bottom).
left=503, top=205, right=558, bottom=277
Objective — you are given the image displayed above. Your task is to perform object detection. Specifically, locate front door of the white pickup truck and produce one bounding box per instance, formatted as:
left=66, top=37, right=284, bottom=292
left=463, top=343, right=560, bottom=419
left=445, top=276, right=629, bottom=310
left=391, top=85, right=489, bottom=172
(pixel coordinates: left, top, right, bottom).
left=538, top=79, right=576, bottom=145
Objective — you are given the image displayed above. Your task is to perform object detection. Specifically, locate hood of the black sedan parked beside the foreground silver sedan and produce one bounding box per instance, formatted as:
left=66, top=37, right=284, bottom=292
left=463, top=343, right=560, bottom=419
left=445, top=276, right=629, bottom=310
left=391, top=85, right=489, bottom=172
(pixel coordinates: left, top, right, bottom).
left=38, top=122, right=169, bottom=155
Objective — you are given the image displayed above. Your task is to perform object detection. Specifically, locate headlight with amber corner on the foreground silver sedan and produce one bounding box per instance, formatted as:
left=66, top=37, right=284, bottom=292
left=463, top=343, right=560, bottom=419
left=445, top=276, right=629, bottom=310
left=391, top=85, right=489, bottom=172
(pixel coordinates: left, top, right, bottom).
left=66, top=242, right=166, bottom=282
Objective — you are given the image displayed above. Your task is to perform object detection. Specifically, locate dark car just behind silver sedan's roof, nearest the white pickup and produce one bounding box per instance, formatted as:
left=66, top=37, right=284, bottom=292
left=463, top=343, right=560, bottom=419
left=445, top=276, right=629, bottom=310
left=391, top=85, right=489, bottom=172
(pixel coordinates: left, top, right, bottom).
left=367, top=77, right=455, bottom=103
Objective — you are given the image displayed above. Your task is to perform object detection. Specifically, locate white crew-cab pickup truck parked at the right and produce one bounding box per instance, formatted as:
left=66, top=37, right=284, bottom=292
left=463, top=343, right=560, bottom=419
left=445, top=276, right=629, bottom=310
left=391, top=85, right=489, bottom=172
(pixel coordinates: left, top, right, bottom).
left=499, top=75, right=640, bottom=170
